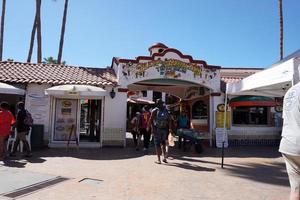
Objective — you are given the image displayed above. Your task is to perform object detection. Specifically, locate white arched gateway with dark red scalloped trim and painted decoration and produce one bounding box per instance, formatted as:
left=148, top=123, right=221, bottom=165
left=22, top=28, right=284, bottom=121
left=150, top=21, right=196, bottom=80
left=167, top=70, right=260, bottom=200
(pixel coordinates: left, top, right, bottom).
left=111, top=43, right=220, bottom=146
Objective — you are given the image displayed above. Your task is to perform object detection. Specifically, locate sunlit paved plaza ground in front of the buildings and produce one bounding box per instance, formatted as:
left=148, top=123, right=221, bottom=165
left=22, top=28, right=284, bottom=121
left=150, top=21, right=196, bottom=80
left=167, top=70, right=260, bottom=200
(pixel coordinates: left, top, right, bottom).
left=0, top=141, right=289, bottom=200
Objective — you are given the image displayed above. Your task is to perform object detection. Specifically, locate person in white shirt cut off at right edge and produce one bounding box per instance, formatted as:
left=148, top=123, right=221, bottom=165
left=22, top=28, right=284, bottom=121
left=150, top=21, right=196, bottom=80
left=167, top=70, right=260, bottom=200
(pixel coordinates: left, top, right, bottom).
left=279, top=82, right=300, bottom=200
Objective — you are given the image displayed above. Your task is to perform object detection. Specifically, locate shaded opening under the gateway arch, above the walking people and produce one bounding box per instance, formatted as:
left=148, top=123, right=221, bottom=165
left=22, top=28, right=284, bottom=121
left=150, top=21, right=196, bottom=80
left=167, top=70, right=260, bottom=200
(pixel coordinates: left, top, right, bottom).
left=127, top=79, right=211, bottom=137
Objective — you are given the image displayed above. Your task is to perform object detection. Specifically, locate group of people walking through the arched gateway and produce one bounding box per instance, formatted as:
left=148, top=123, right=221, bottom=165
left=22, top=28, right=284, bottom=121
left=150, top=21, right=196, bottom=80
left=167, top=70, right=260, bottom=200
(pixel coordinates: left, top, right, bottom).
left=131, top=99, right=189, bottom=164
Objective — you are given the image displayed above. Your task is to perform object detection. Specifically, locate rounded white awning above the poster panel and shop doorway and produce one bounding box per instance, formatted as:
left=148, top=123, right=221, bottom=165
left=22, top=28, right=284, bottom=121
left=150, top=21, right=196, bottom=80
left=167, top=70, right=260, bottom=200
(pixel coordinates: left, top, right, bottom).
left=45, top=85, right=107, bottom=99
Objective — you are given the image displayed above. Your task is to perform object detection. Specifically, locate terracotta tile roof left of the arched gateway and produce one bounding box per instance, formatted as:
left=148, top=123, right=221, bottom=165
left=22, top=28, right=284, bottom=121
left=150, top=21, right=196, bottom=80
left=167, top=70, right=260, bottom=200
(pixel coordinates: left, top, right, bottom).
left=0, top=62, right=117, bottom=86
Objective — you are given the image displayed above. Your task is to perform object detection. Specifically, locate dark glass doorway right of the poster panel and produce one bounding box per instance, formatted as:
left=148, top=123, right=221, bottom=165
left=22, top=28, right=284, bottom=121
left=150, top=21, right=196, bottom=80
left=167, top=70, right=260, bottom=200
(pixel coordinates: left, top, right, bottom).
left=79, top=99, right=102, bottom=142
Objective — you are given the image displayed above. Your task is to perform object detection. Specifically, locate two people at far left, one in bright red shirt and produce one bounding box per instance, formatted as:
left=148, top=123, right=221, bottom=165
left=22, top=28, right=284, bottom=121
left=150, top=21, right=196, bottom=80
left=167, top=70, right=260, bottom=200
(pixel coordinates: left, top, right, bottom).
left=0, top=102, right=31, bottom=160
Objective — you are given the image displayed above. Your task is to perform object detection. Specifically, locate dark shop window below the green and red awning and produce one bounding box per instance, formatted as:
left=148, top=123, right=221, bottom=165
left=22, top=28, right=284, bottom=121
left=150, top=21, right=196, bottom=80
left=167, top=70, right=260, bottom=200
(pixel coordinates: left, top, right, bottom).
left=233, top=106, right=269, bottom=125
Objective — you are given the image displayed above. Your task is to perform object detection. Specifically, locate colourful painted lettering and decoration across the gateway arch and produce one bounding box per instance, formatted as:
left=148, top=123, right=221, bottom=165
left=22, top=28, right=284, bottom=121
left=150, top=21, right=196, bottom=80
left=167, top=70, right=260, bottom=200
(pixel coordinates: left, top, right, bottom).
left=122, top=59, right=216, bottom=79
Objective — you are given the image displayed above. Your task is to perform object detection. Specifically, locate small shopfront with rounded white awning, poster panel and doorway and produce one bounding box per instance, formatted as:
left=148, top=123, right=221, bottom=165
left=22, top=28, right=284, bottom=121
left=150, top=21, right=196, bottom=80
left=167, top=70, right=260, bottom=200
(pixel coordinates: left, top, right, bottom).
left=45, top=85, right=107, bottom=147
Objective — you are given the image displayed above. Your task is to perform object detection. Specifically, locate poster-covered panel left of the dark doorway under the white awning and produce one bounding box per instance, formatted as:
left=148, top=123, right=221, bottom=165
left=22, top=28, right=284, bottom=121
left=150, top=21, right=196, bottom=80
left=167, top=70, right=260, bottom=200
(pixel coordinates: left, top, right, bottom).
left=53, top=99, right=78, bottom=141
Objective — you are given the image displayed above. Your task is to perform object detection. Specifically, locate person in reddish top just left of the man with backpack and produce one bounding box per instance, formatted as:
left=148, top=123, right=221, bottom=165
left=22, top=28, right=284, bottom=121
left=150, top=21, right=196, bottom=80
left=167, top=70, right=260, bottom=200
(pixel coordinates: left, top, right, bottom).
left=139, top=105, right=151, bottom=153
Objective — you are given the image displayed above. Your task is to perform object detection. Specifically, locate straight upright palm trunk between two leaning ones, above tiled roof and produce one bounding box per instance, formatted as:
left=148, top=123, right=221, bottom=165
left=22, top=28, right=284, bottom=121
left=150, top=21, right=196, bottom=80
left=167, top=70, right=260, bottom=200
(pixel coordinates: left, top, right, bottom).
left=36, top=0, right=42, bottom=63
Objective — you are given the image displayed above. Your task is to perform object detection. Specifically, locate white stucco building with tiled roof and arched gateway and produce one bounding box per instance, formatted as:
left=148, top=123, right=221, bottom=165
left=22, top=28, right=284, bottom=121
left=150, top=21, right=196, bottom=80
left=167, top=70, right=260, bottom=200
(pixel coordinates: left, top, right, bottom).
left=0, top=43, right=277, bottom=147
